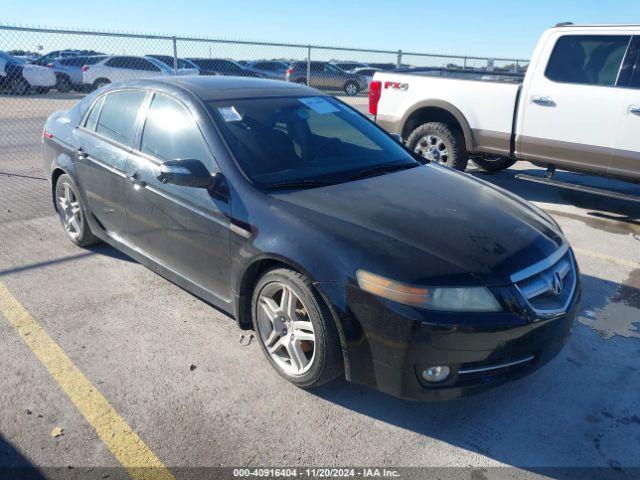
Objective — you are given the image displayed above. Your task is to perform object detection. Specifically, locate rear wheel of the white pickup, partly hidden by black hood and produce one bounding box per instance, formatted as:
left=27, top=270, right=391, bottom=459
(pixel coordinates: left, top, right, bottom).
left=407, top=122, right=469, bottom=172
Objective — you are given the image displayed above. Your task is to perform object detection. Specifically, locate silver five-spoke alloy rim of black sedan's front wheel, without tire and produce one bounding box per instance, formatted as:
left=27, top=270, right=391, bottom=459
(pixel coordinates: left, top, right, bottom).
left=256, top=282, right=316, bottom=376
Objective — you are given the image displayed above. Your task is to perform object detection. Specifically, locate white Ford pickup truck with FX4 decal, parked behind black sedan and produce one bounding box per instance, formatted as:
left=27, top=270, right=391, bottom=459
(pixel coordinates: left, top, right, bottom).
left=369, top=24, right=640, bottom=186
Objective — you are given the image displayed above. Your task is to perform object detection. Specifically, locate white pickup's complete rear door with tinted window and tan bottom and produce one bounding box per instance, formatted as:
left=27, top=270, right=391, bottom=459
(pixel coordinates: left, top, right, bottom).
left=517, top=33, right=631, bottom=173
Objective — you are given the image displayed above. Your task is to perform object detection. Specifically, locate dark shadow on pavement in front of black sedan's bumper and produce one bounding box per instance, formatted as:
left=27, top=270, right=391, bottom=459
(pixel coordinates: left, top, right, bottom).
left=313, top=276, right=640, bottom=478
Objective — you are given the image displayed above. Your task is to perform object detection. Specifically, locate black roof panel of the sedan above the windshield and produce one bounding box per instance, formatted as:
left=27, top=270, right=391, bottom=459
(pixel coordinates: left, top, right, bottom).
left=111, top=75, right=325, bottom=102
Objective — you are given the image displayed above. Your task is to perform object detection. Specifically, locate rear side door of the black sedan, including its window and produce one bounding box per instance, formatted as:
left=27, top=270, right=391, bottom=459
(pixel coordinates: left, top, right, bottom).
left=74, top=90, right=146, bottom=236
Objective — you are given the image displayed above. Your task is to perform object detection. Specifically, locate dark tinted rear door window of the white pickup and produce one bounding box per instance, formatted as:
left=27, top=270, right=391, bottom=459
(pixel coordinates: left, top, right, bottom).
left=545, top=35, right=631, bottom=87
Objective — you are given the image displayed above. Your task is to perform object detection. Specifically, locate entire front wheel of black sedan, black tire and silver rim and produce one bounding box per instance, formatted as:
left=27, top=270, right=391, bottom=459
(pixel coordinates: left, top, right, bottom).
left=251, top=268, right=344, bottom=388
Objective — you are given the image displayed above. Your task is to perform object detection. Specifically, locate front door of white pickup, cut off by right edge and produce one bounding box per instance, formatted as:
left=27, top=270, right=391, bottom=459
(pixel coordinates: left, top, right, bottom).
left=609, top=35, right=640, bottom=180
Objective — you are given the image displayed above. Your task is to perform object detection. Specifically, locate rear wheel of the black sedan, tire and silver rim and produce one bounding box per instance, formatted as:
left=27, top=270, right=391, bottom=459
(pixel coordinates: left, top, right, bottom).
left=55, top=174, right=100, bottom=247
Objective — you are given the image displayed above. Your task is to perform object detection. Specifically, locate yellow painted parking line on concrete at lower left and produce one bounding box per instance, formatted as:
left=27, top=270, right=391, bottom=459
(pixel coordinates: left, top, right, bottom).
left=0, top=282, right=175, bottom=480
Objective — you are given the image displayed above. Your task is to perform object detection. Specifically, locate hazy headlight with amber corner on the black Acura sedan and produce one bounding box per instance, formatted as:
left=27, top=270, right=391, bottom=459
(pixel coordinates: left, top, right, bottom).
left=356, top=270, right=502, bottom=312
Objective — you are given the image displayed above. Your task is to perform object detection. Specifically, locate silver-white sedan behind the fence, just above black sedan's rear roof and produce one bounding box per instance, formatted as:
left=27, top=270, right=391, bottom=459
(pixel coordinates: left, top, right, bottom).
left=82, top=55, right=178, bottom=90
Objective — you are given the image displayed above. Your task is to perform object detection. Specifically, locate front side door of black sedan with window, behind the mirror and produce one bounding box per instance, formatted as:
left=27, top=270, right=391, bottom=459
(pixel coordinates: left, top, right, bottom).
left=124, top=93, right=230, bottom=300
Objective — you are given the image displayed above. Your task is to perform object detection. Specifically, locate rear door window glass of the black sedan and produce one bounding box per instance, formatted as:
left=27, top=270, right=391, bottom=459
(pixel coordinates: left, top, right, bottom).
left=96, top=91, right=146, bottom=145
